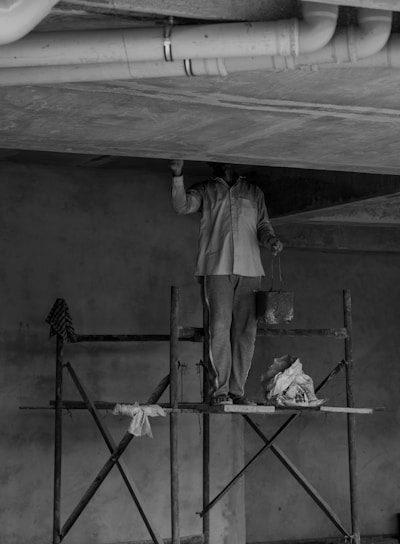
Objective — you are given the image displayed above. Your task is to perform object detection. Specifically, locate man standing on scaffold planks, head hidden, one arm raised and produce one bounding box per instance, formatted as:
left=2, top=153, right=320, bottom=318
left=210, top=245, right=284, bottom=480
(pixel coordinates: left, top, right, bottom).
left=170, top=160, right=283, bottom=405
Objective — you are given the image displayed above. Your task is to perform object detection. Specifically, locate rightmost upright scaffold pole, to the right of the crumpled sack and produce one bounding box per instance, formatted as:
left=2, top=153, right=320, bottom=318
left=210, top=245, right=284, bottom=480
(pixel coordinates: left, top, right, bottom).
left=343, top=289, right=361, bottom=544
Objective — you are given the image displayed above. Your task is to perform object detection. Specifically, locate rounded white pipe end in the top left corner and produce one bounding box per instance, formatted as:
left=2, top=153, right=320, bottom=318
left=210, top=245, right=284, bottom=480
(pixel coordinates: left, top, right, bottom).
left=0, top=0, right=59, bottom=45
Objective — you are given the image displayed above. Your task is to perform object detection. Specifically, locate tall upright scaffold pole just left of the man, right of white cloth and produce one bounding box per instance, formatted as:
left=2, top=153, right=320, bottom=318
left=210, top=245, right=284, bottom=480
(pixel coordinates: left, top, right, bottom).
left=170, top=287, right=180, bottom=544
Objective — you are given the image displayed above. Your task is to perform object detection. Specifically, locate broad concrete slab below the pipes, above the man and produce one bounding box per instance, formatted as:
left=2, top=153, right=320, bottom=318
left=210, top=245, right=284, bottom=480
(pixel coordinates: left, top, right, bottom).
left=0, top=64, right=400, bottom=175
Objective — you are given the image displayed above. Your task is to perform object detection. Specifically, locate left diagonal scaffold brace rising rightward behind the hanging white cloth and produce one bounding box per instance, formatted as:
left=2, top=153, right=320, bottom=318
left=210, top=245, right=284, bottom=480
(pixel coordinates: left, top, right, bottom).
left=60, top=375, right=169, bottom=544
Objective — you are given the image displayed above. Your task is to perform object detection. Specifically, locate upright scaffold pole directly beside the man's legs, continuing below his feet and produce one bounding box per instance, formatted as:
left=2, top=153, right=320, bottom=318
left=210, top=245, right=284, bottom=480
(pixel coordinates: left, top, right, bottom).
left=203, top=304, right=210, bottom=544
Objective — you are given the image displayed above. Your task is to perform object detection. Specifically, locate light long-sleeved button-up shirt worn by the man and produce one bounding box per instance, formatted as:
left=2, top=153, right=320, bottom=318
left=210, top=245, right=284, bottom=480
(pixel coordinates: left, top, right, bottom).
left=172, top=176, right=276, bottom=276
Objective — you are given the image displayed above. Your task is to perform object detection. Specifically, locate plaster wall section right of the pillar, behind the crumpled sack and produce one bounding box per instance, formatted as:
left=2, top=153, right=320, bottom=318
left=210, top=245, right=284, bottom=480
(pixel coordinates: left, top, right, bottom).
left=245, top=251, right=400, bottom=543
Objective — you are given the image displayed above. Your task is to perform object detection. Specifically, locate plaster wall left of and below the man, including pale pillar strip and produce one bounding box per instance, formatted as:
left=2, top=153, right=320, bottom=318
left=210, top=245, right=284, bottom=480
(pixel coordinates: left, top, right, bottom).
left=0, top=163, right=245, bottom=544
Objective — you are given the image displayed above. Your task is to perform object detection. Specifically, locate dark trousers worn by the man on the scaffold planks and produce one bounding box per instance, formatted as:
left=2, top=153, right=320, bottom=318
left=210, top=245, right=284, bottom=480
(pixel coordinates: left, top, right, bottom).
left=202, top=274, right=261, bottom=396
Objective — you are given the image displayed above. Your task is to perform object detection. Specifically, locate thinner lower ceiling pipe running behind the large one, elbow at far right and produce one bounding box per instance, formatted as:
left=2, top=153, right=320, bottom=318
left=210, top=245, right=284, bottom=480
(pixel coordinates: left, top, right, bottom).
left=0, top=4, right=392, bottom=86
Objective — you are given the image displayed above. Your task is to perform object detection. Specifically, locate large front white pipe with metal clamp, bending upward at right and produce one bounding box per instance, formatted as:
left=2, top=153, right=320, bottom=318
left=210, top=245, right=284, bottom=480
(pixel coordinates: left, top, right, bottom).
left=0, top=0, right=338, bottom=68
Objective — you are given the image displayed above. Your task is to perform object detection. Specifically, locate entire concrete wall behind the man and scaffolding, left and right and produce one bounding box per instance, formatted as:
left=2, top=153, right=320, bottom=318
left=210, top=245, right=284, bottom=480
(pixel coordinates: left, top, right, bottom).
left=0, top=163, right=400, bottom=544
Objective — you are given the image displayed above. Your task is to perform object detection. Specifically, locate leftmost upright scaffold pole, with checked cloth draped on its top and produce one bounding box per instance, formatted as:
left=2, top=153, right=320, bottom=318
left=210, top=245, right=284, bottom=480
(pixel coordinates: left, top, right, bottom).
left=53, top=334, right=64, bottom=544
